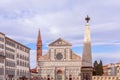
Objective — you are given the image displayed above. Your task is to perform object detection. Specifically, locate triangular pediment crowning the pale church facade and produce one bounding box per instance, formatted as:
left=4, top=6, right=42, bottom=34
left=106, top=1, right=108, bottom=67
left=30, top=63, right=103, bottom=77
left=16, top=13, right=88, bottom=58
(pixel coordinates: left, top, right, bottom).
left=49, top=38, right=72, bottom=46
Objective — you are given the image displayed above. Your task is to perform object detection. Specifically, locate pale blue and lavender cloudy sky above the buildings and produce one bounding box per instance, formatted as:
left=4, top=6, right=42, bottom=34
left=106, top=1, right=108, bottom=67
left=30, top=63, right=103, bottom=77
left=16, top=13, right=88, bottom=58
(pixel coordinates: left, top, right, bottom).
left=0, top=0, right=120, bottom=68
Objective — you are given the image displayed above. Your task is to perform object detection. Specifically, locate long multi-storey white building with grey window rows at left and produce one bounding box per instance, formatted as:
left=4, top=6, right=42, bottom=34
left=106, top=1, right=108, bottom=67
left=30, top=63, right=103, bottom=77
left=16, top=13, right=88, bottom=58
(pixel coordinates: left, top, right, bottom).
left=0, top=32, right=30, bottom=80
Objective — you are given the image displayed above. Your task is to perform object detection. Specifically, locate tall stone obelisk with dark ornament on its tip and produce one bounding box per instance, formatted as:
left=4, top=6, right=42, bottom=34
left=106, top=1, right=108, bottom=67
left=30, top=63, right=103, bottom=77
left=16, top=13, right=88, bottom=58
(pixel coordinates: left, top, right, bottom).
left=81, top=16, right=93, bottom=80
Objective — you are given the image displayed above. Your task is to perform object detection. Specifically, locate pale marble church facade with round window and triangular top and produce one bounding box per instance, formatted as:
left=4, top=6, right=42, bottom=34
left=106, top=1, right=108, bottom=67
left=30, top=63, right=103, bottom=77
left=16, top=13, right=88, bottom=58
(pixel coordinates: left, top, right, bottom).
left=38, top=38, right=81, bottom=80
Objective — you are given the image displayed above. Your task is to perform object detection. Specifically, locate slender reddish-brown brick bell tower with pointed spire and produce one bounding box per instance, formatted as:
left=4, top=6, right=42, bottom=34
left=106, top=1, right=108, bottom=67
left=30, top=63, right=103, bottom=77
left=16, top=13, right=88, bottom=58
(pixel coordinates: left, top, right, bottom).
left=36, top=30, right=42, bottom=62
